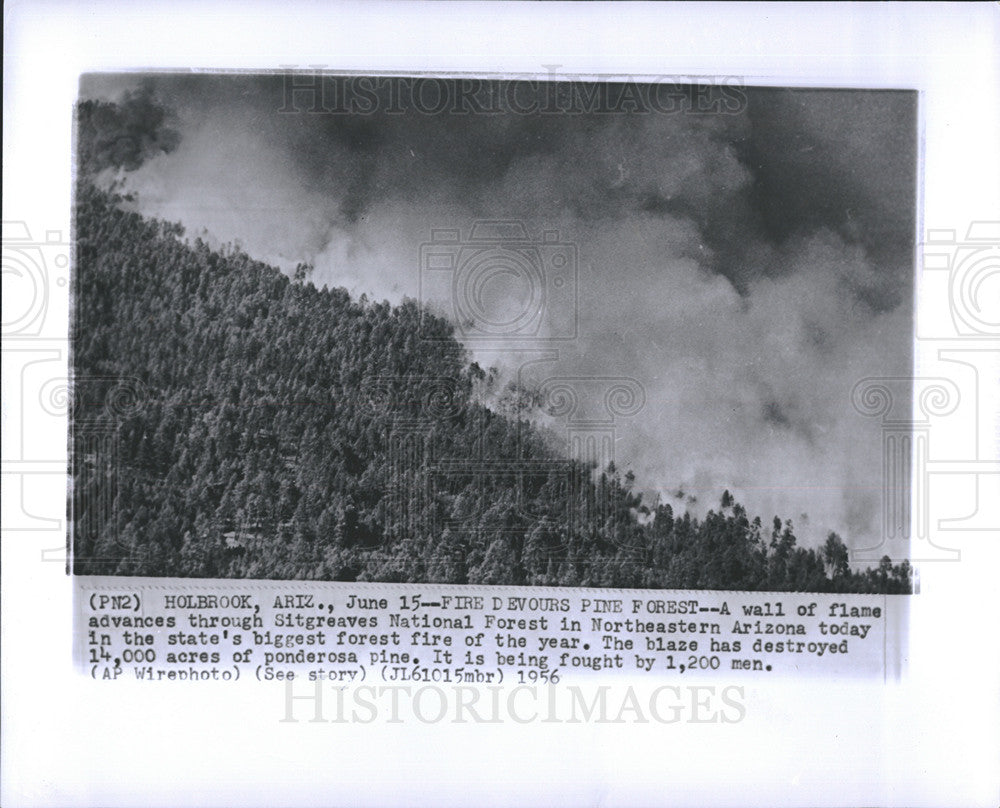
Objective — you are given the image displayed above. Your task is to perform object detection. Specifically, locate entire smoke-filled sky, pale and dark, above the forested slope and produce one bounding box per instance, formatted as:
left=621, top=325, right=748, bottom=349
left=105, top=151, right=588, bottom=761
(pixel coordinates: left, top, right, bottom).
left=82, top=76, right=916, bottom=545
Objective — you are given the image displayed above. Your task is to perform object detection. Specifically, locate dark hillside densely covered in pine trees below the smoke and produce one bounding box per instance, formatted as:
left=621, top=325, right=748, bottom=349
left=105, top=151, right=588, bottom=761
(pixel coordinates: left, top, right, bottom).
left=71, top=179, right=911, bottom=593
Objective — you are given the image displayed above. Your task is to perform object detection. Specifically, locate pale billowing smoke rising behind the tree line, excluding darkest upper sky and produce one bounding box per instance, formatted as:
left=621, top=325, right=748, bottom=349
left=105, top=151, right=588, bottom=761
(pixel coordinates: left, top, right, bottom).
left=95, top=77, right=911, bottom=546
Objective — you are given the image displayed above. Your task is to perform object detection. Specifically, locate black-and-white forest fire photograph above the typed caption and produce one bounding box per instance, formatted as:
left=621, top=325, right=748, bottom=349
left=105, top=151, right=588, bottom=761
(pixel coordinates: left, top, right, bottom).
left=69, top=71, right=917, bottom=594
